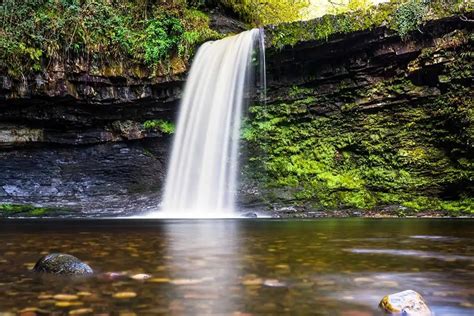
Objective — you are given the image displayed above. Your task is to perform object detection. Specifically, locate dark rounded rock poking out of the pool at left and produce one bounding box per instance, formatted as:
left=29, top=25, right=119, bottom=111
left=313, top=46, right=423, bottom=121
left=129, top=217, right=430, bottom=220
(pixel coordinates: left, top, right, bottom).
left=33, top=253, right=94, bottom=275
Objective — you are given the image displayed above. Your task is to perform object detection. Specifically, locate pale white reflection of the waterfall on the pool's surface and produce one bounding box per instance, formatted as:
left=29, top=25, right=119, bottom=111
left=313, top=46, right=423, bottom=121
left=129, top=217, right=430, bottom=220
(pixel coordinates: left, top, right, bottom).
left=164, top=220, right=241, bottom=314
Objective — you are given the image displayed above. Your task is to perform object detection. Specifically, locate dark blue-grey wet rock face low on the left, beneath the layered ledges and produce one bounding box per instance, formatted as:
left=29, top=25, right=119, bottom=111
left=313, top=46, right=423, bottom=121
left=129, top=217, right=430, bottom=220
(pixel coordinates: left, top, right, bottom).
left=0, top=139, right=168, bottom=209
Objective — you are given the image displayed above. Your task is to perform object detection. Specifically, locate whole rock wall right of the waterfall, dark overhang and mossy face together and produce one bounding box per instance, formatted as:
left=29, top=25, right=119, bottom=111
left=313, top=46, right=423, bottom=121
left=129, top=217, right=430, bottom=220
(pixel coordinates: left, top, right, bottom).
left=242, top=15, right=474, bottom=212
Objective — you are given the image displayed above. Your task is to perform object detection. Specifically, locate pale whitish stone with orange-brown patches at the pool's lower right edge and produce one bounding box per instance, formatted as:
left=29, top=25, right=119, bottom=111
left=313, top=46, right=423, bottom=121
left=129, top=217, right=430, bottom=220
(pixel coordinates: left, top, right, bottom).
left=379, top=290, right=432, bottom=316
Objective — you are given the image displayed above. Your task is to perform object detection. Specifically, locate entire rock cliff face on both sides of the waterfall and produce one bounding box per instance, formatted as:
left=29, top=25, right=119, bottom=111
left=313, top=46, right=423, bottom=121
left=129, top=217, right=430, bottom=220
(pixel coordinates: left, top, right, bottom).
left=0, top=13, right=474, bottom=214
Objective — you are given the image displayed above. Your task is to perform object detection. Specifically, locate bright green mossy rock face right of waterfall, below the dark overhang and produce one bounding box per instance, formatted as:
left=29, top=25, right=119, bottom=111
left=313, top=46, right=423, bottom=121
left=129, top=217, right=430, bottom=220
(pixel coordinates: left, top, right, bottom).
left=242, top=28, right=474, bottom=213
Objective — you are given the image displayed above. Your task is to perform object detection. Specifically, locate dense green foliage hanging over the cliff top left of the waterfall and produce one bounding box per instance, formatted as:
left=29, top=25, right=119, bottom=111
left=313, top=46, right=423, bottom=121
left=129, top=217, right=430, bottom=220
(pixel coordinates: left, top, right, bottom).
left=0, top=0, right=220, bottom=77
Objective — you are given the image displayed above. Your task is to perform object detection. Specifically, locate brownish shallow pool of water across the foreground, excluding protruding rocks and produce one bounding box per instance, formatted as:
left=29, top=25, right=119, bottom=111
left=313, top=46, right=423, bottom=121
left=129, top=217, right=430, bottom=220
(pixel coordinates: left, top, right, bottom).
left=0, top=219, right=474, bottom=316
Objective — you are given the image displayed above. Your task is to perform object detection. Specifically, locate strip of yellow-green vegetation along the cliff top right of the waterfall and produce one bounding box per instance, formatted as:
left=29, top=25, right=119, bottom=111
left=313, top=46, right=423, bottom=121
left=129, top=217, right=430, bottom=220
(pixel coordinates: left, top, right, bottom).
left=266, top=0, right=473, bottom=48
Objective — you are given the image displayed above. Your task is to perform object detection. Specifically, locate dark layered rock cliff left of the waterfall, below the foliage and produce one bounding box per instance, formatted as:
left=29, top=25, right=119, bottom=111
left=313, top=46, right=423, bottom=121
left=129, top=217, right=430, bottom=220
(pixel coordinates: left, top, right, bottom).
left=0, top=60, right=186, bottom=210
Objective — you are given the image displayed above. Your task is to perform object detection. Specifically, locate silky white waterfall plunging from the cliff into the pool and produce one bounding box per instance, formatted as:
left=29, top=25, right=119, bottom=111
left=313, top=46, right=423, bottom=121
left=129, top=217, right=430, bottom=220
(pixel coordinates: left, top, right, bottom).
left=156, top=29, right=262, bottom=218
